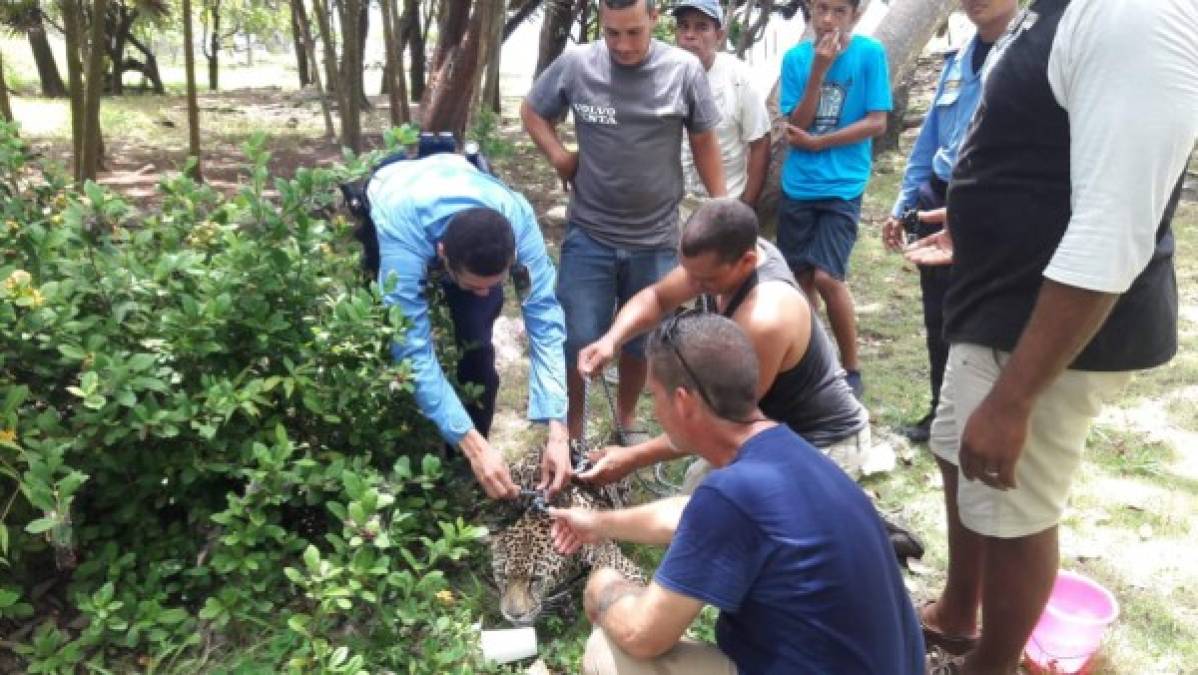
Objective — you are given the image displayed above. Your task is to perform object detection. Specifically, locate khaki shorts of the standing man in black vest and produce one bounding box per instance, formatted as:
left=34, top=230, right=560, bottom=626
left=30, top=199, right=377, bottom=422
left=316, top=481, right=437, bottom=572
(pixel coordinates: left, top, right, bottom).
left=928, top=344, right=1131, bottom=538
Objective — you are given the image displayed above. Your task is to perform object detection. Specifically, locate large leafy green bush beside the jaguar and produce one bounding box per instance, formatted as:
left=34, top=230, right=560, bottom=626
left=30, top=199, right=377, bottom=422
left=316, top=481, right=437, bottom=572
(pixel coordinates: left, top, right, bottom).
left=0, top=123, right=495, bottom=673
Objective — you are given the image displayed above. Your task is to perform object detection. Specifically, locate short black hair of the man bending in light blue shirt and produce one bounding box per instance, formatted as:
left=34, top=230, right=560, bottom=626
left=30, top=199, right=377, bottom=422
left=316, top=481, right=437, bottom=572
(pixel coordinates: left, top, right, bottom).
left=441, top=207, right=516, bottom=277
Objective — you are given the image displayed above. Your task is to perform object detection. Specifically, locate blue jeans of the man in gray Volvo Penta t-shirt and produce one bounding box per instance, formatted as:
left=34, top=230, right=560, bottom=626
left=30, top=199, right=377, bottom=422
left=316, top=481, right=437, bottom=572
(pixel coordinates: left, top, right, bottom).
left=557, top=223, right=678, bottom=368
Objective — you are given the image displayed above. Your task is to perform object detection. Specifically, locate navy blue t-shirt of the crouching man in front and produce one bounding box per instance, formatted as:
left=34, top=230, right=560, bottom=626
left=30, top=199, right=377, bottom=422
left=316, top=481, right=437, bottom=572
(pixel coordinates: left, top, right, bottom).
left=655, top=424, right=924, bottom=675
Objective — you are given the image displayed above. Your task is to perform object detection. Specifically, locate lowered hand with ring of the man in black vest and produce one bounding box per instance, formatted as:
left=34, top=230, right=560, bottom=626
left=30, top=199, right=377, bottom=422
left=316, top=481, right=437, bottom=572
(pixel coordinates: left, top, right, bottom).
left=957, top=391, right=1031, bottom=490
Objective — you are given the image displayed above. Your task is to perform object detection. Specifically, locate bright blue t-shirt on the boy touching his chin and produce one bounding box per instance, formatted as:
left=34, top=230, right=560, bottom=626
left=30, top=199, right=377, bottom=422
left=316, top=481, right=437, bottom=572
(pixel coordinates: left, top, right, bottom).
left=779, top=35, right=893, bottom=199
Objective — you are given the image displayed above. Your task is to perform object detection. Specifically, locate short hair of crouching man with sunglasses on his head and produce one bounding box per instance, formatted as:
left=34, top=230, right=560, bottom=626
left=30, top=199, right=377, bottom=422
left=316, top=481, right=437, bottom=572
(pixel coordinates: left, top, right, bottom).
left=646, top=311, right=758, bottom=422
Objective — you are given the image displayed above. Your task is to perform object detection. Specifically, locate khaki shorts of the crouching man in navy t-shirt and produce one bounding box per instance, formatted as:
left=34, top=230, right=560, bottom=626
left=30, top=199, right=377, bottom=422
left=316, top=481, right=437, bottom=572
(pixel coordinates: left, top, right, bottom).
left=582, top=627, right=737, bottom=675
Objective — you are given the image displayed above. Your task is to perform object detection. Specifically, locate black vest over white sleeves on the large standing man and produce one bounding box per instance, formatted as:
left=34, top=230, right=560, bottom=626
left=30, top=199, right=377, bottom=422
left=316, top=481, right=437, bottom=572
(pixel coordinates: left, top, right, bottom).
left=944, top=0, right=1181, bottom=370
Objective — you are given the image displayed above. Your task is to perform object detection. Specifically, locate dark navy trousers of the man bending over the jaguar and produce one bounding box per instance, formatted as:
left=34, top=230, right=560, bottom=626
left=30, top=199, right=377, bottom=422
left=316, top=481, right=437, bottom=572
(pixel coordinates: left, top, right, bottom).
left=441, top=279, right=503, bottom=436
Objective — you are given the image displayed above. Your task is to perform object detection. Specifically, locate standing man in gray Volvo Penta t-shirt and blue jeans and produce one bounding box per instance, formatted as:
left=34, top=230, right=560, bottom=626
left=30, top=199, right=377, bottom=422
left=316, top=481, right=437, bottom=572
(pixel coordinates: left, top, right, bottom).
left=520, top=0, right=725, bottom=438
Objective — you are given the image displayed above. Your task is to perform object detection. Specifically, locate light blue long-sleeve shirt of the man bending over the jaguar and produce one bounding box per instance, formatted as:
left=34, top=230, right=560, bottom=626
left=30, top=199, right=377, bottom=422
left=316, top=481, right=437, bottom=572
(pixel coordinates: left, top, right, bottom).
left=367, top=153, right=567, bottom=445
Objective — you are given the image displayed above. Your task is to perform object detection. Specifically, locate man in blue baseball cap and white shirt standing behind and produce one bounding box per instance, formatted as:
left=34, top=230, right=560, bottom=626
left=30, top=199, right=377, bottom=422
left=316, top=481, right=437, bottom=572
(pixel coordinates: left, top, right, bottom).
left=673, top=0, right=769, bottom=210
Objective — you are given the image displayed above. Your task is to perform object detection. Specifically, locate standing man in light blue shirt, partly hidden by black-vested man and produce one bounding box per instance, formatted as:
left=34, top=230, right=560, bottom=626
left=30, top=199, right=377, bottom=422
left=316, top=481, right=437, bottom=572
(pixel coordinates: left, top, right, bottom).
left=882, top=0, right=1018, bottom=442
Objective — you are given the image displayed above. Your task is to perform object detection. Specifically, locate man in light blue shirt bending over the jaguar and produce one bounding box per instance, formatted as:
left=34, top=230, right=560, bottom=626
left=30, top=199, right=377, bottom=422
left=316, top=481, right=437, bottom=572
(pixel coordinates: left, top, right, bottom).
left=367, top=153, right=570, bottom=499
